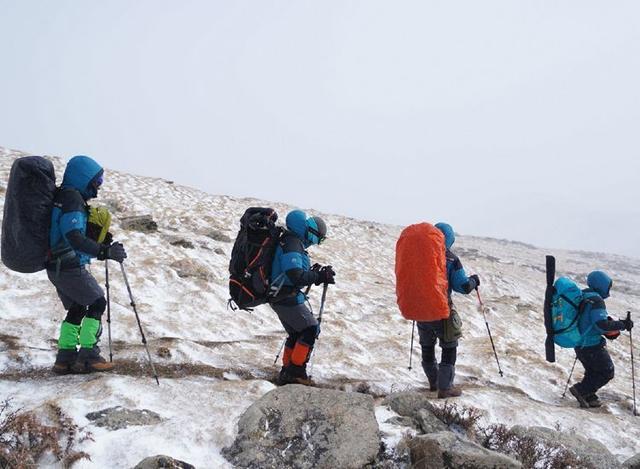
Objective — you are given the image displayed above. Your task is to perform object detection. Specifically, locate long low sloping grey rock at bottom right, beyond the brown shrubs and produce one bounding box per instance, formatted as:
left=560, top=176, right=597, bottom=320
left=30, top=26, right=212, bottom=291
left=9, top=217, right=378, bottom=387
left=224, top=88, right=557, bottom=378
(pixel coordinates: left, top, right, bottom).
left=511, top=425, right=620, bottom=469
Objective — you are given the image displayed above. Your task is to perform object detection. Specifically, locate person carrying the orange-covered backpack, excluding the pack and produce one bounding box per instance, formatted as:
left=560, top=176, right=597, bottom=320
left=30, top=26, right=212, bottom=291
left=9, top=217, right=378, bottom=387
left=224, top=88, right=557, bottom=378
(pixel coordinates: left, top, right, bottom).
left=418, top=223, right=480, bottom=398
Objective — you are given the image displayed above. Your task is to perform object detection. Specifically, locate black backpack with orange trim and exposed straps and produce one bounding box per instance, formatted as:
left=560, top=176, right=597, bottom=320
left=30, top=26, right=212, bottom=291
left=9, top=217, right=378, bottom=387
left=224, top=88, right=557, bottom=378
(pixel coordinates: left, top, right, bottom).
left=229, top=207, right=283, bottom=311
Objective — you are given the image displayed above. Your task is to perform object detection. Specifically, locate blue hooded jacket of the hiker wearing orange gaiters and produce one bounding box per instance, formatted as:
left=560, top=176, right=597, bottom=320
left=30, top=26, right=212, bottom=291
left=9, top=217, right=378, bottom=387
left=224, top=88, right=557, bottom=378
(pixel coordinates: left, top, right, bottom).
left=271, top=210, right=321, bottom=305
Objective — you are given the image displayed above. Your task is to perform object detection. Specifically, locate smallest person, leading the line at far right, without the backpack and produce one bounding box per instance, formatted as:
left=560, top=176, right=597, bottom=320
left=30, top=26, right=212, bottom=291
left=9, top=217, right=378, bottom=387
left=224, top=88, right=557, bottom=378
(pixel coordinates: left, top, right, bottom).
left=569, top=270, right=633, bottom=408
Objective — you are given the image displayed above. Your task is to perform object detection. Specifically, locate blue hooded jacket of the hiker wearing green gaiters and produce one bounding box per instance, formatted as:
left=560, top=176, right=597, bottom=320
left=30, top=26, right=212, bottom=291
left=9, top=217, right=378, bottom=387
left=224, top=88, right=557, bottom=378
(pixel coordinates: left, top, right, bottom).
left=49, top=156, right=104, bottom=266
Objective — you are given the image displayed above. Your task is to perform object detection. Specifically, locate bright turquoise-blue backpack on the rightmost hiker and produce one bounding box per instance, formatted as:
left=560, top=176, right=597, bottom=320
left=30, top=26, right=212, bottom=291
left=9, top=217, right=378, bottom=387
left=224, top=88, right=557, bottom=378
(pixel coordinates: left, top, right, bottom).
left=551, top=277, right=585, bottom=348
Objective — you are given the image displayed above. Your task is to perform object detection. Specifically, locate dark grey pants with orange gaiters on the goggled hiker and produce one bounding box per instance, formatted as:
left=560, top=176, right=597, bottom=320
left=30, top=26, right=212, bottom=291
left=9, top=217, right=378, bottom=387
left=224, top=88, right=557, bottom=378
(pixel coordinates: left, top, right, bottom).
left=271, top=303, right=319, bottom=367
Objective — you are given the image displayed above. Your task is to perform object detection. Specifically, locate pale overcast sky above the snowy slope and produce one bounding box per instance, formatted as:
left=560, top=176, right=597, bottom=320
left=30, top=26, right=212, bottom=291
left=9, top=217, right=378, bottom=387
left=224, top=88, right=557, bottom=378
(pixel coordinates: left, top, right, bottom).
left=0, top=0, right=640, bottom=257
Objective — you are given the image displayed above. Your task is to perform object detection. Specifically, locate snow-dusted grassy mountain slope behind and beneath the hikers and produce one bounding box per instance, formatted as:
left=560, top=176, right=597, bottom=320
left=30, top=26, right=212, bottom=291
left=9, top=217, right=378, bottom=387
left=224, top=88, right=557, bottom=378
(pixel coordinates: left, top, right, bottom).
left=0, top=149, right=640, bottom=467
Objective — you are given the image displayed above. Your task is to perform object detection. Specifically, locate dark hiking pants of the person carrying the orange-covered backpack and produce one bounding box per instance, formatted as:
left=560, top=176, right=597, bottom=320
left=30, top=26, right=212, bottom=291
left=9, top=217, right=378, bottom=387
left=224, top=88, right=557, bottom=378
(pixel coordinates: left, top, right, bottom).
left=418, top=320, right=458, bottom=390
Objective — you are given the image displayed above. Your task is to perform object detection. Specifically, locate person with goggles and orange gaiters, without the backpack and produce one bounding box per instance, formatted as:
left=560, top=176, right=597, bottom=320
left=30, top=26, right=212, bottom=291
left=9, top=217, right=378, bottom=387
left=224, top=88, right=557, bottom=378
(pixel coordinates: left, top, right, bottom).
left=269, top=210, right=335, bottom=385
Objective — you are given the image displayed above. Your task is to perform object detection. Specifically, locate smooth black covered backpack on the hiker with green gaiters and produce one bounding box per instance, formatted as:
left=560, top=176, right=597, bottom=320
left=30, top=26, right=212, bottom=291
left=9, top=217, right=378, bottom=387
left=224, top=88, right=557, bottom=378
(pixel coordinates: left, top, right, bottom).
left=2, top=156, right=56, bottom=274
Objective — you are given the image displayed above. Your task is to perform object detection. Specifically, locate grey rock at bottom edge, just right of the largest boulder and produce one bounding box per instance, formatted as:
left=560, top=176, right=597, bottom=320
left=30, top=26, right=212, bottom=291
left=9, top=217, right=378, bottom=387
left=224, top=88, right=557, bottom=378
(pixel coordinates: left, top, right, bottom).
left=408, top=431, right=522, bottom=469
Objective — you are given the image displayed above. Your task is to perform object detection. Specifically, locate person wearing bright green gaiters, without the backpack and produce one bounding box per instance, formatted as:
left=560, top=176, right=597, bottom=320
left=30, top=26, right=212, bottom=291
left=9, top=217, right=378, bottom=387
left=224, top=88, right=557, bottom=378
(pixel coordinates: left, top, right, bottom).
left=46, top=156, right=127, bottom=374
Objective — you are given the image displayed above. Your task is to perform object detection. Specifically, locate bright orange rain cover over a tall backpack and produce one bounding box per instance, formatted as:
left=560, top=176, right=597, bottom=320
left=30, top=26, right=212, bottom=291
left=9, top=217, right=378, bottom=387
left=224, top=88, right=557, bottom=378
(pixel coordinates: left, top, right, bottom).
left=396, top=223, right=449, bottom=321
